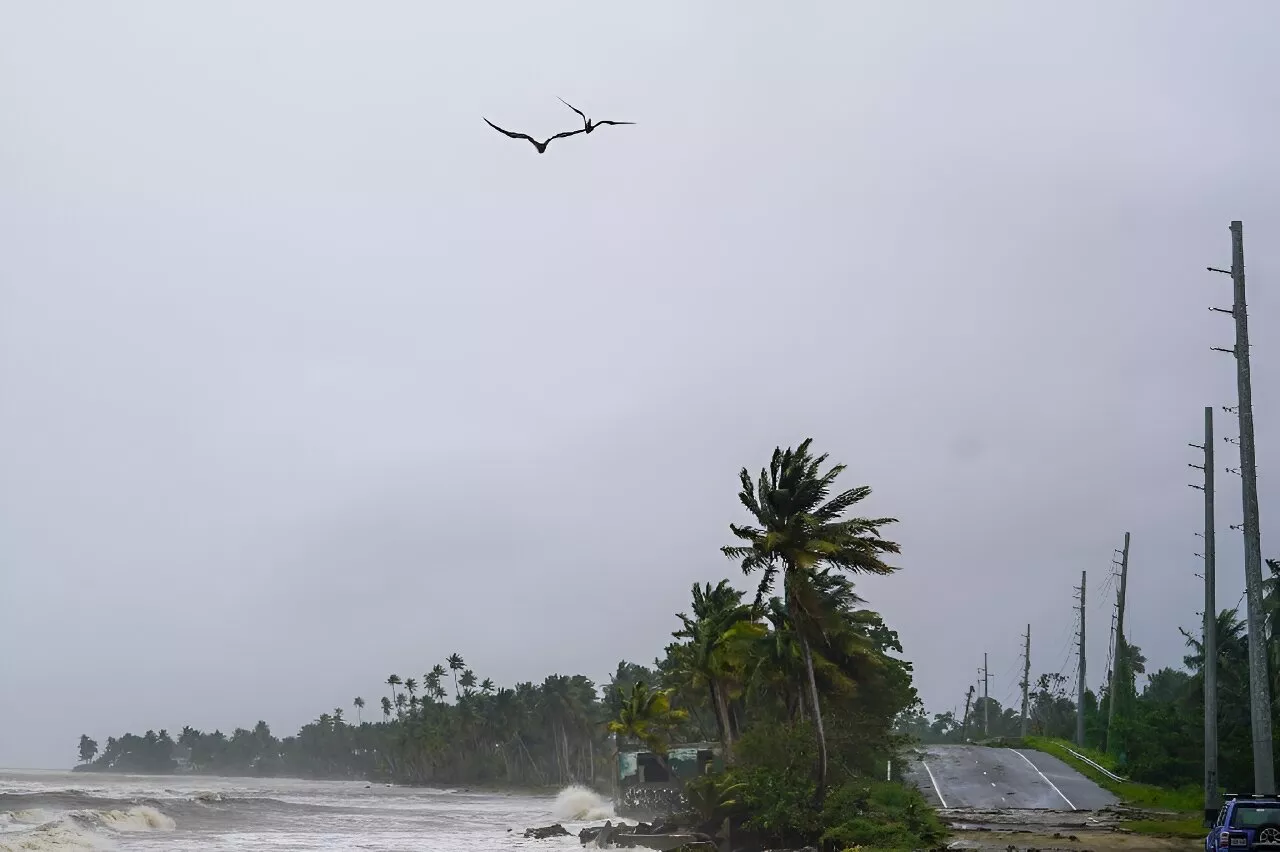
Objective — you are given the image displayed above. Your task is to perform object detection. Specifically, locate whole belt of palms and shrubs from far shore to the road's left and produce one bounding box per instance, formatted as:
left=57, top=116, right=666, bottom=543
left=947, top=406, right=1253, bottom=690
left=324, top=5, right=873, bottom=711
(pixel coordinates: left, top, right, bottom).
left=81, top=440, right=940, bottom=848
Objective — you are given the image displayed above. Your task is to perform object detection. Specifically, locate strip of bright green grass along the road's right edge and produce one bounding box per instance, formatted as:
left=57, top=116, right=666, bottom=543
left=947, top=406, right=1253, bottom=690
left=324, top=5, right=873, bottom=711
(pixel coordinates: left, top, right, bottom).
left=1021, top=737, right=1204, bottom=838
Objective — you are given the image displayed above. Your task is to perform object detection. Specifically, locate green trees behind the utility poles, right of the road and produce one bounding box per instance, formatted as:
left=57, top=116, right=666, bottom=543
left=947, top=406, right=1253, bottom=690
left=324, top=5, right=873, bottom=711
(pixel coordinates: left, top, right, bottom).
left=900, top=559, right=1280, bottom=793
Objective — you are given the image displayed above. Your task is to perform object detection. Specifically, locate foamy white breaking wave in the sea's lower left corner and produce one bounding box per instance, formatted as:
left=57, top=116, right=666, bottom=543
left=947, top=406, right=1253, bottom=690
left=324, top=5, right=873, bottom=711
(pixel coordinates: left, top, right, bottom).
left=0, top=805, right=175, bottom=852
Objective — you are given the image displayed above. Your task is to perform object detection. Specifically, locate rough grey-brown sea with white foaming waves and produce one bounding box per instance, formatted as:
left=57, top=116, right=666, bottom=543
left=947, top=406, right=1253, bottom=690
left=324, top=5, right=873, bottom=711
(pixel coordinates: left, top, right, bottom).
left=0, top=771, right=613, bottom=852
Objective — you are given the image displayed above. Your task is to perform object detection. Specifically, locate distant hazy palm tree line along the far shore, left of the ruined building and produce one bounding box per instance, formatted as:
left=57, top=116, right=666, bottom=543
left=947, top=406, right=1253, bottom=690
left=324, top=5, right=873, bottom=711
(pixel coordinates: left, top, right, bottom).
left=79, top=654, right=619, bottom=785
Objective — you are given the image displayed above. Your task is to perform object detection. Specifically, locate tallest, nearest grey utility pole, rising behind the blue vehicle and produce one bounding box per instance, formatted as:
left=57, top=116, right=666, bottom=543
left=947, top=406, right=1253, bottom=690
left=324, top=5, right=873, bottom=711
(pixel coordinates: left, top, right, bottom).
left=1210, top=220, right=1276, bottom=796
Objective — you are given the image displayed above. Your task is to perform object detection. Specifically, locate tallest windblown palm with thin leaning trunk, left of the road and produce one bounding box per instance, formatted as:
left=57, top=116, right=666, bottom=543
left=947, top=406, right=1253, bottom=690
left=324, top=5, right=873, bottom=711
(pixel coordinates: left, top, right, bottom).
left=721, top=439, right=899, bottom=802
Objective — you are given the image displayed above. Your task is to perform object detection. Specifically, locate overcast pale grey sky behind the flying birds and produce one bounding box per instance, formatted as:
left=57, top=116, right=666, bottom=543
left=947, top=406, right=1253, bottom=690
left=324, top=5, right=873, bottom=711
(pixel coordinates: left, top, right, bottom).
left=0, top=0, right=1280, bottom=766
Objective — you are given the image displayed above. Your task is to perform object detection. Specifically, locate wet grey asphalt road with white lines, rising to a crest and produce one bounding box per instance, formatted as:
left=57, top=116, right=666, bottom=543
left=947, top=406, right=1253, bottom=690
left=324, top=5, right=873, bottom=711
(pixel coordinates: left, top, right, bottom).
left=908, top=746, right=1116, bottom=811
